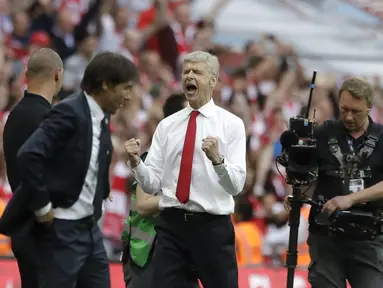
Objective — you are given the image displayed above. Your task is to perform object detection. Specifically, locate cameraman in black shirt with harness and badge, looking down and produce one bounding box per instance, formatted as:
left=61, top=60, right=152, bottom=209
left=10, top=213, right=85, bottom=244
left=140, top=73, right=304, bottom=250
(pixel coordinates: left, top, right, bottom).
left=290, top=78, right=383, bottom=288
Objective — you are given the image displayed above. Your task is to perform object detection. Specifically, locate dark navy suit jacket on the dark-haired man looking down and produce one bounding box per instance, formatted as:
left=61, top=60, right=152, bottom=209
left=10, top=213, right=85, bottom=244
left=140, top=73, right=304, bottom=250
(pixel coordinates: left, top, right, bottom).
left=0, top=93, right=112, bottom=234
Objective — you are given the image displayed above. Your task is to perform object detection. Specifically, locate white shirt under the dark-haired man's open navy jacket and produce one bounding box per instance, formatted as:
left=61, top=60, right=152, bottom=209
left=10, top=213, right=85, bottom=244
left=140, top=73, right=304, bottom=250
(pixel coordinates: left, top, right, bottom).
left=54, top=94, right=105, bottom=220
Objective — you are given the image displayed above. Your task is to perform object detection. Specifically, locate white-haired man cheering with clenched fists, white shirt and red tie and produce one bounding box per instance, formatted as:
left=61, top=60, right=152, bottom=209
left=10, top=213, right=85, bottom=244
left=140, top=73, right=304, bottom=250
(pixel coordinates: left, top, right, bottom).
left=125, top=51, right=246, bottom=288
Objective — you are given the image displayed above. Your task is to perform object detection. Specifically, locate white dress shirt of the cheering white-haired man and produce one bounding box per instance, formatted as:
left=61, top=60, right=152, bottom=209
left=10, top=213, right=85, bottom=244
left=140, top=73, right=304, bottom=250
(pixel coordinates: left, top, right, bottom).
left=132, top=100, right=246, bottom=215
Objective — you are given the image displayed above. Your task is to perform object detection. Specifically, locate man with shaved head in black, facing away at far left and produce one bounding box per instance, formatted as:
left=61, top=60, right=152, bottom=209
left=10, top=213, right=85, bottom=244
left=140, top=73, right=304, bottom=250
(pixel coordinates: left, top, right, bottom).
left=3, top=48, right=63, bottom=288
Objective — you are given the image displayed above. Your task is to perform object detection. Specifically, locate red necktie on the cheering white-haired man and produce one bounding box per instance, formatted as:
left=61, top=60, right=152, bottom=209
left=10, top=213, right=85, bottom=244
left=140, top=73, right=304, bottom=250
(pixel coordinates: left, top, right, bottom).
left=176, top=110, right=199, bottom=204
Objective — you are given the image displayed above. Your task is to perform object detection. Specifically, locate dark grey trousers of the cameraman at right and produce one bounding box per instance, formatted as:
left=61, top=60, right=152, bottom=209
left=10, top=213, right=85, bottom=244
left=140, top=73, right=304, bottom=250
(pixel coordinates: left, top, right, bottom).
left=307, top=233, right=383, bottom=288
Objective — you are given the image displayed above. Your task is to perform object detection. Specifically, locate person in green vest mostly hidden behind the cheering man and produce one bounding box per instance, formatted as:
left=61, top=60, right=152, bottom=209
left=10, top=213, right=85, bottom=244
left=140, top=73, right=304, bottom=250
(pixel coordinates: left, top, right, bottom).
left=122, top=93, right=199, bottom=288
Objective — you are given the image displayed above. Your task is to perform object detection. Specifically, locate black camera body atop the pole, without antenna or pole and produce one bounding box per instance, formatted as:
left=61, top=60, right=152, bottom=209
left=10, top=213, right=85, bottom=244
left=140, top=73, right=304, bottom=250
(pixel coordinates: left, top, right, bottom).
left=277, top=116, right=318, bottom=185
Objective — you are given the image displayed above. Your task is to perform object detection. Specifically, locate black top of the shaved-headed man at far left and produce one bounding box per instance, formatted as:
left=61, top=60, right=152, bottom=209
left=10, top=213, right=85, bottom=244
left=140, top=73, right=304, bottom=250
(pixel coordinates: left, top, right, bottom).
left=0, top=92, right=51, bottom=234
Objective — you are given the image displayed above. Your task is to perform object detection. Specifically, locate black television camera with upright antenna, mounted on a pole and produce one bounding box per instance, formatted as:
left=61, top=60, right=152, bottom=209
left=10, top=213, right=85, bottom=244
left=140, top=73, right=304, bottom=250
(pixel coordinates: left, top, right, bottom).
left=276, top=71, right=318, bottom=288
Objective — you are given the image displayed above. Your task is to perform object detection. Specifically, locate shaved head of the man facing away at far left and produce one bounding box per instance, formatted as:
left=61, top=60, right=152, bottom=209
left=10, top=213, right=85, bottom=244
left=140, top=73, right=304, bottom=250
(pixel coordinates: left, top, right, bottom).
left=27, top=48, right=63, bottom=81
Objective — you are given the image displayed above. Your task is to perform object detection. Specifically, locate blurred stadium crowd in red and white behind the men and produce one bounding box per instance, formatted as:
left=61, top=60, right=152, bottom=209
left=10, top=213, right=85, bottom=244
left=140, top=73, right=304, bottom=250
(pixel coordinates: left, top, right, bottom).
left=0, top=0, right=383, bottom=265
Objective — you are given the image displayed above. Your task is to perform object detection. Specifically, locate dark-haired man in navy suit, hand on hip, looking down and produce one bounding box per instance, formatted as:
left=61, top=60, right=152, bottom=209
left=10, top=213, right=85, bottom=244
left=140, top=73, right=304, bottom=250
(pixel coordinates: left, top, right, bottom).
left=17, top=52, right=139, bottom=288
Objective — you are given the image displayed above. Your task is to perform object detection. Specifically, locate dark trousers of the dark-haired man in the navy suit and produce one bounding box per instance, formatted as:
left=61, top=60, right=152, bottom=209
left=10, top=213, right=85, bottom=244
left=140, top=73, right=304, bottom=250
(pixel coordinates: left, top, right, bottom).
left=36, top=217, right=110, bottom=288
